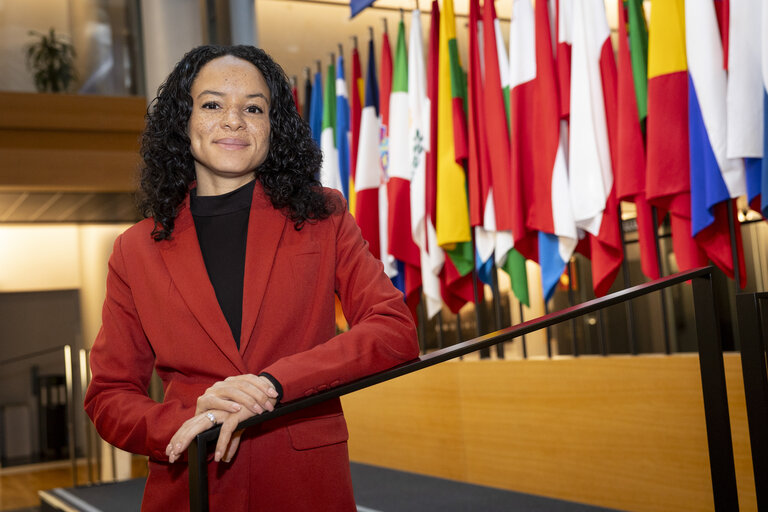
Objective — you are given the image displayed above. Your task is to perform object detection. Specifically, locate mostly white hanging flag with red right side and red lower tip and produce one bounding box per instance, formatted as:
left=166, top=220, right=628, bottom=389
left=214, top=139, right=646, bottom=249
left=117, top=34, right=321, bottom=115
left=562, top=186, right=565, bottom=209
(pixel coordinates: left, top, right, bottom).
left=568, top=0, right=624, bottom=297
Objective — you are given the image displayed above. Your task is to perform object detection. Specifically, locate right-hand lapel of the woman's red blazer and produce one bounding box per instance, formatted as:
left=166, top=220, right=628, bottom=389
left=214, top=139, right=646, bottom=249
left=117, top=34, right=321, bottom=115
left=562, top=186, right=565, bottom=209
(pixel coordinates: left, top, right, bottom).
left=240, top=181, right=287, bottom=354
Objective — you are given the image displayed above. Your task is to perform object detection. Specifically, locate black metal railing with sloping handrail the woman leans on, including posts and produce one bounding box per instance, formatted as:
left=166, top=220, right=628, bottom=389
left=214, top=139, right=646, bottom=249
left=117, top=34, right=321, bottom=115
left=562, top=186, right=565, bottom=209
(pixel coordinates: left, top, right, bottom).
left=188, top=267, right=739, bottom=512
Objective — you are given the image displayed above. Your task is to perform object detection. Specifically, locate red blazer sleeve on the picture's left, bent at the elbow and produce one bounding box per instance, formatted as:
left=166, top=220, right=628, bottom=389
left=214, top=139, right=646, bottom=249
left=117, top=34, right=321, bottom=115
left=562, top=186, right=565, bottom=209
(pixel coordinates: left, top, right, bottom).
left=85, top=235, right=194, bottom=460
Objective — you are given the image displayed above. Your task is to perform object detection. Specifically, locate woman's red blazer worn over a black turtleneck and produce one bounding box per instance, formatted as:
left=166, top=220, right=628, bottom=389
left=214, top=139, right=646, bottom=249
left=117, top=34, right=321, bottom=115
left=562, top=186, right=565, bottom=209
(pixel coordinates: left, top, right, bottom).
left=85, top=183, right=418, bottom=512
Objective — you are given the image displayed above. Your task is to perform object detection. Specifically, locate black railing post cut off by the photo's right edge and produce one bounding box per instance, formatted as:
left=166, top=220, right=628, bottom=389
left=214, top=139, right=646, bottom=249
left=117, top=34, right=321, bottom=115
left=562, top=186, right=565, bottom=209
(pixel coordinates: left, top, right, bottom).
left=736, top=293, right=768, bottom=512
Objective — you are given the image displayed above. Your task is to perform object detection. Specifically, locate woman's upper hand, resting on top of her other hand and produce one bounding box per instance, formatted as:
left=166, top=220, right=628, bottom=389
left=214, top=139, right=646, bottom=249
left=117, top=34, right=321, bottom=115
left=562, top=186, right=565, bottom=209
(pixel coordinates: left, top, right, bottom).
left=195, top=374, right=277, bottom=415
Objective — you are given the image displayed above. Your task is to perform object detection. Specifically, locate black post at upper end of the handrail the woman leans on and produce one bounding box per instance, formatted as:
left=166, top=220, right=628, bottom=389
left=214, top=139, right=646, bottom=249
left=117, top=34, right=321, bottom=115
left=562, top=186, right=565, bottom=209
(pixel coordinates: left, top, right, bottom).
left=692, top=273, right=739, bottom=512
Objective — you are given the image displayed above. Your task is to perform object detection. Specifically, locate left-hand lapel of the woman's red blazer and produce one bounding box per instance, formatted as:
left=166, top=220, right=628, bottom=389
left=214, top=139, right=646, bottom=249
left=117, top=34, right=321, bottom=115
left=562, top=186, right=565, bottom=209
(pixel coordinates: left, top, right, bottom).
left=159, top=196, right=246, bottom=373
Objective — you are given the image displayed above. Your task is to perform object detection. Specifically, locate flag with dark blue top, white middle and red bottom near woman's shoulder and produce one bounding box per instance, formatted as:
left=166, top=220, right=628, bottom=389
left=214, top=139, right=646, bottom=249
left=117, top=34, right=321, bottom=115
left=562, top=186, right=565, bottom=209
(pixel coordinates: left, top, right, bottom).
left=355, top=39, right=382, bottom=259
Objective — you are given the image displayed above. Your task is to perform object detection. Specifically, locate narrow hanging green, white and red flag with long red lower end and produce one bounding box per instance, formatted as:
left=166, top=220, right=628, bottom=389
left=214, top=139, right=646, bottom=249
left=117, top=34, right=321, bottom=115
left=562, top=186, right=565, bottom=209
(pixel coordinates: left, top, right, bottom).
left=387, top=20, right=421, bottom=318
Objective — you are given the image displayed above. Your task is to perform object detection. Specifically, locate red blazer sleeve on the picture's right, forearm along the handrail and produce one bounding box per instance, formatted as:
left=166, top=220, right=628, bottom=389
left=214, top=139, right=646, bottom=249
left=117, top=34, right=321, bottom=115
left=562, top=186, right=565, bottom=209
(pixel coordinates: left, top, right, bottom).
left=263, top=202, right=419, bottom=401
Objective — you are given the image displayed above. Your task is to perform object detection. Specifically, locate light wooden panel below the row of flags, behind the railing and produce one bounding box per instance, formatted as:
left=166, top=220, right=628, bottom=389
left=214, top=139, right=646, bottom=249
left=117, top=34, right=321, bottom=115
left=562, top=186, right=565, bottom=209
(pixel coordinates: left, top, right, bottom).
left=344, top=355, right=756, bottom=512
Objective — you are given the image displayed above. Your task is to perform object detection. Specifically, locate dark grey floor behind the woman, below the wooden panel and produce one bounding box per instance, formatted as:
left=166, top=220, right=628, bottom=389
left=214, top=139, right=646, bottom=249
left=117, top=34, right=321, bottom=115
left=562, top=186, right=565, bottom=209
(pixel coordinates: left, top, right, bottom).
left=33, top=463, right=628, bottom=512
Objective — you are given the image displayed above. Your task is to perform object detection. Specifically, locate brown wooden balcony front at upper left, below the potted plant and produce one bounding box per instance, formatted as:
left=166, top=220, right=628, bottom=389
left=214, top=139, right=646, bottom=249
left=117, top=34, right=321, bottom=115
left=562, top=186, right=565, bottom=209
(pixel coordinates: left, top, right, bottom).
left=0, top=92, right=146, bottom=192
